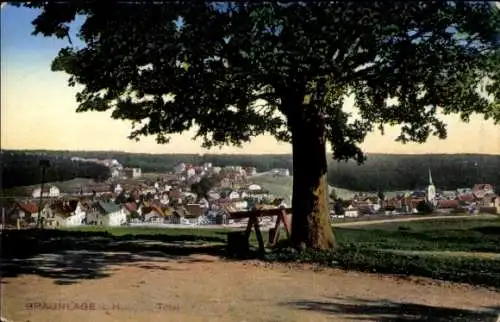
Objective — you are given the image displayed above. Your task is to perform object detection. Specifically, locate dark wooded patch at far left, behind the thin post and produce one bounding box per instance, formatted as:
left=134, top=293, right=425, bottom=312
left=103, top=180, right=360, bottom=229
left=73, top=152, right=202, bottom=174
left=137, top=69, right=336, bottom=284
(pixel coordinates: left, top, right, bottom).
left=0, top=151, right=110, bottom=189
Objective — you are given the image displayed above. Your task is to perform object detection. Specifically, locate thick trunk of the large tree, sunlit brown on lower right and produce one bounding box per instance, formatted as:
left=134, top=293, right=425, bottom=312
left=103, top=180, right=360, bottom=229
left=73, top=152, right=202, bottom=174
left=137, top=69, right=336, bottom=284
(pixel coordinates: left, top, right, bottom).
left=288, top=97, right=336, bottom=250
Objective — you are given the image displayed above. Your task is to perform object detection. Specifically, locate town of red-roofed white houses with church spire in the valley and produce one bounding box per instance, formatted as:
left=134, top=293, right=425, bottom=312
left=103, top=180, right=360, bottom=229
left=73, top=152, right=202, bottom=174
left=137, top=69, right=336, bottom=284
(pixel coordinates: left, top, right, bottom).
left=2, top=157, right=500, bottom=228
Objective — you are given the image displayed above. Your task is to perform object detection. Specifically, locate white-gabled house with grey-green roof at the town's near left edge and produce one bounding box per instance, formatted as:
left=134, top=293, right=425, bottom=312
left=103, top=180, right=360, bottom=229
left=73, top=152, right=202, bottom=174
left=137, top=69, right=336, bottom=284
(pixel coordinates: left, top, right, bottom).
left=87, top=201, right=127, bottom=227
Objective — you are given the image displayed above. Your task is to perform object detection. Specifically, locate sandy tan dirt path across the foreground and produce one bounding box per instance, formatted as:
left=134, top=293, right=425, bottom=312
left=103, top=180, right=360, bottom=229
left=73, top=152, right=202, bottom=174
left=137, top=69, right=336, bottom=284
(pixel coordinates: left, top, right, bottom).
left=2, top=255, right=500, bottom=322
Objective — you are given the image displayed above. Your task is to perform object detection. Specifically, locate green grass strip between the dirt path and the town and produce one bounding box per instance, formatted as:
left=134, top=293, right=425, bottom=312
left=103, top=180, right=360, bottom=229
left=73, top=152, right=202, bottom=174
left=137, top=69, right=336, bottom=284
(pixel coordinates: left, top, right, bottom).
left=2, top=217, right=500, bottom=288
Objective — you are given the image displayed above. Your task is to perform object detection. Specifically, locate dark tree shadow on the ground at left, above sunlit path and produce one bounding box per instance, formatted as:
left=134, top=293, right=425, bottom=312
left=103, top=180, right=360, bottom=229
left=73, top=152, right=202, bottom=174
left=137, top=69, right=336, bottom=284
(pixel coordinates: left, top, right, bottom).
left=0, top=230, right=232, bottom=285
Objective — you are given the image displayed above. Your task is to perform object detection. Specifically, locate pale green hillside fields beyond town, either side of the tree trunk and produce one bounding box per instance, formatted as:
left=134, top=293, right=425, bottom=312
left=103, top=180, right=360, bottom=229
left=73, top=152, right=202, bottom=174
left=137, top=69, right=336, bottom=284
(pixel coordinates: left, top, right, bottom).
left=250, top=174, right=354, bottom=202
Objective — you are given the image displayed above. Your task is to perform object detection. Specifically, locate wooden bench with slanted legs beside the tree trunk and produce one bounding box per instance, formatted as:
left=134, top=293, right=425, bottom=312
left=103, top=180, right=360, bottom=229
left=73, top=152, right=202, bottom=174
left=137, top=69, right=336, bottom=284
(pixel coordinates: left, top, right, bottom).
left=229, top=208, right=292, bottom=253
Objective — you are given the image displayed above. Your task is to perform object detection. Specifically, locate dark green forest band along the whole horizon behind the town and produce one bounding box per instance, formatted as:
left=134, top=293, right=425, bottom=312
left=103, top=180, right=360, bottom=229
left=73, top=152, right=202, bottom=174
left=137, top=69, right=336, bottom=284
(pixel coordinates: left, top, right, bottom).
left=2, top=150, right=500, bottom=191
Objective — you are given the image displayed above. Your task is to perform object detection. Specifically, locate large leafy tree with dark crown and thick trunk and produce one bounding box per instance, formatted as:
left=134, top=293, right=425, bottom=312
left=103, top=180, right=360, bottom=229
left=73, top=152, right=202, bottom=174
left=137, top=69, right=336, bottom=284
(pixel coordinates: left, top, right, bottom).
left=27, top=0, right=500, bottom=249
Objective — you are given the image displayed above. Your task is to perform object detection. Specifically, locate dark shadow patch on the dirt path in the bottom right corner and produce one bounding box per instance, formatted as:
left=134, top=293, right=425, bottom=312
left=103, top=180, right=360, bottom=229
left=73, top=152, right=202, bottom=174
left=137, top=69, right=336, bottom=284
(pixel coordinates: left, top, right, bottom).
left=283, top=298, right=500, bottom=322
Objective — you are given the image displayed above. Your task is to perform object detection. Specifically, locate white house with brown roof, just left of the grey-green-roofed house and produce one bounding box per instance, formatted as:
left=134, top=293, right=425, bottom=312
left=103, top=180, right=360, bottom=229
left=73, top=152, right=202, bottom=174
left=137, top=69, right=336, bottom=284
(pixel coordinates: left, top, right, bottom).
left=44, top=200, right=86, bottom=227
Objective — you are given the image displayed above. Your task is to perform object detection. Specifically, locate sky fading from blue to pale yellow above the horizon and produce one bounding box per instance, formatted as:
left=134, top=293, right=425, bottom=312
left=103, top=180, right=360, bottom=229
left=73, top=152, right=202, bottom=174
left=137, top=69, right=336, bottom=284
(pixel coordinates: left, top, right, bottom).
left=0, top=6, right=500, bottom=154
